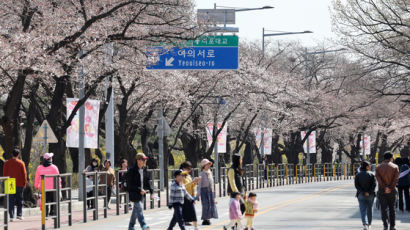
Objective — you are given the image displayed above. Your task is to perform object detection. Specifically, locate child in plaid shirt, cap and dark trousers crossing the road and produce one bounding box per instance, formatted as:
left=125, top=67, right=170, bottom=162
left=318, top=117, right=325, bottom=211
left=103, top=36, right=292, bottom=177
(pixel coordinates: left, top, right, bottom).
left=168, top=169, right=195, bottom=230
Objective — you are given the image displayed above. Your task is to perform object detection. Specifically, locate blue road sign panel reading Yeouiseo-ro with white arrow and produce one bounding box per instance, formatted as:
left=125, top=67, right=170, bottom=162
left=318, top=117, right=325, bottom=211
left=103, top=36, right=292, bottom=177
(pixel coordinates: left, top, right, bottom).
left=147, top=46, right=238, bottom=70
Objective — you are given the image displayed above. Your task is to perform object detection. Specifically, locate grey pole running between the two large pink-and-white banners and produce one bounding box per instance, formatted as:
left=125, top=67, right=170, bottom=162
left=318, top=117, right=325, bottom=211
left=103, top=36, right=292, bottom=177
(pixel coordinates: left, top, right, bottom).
left=78, top=50, right=85, bottom=201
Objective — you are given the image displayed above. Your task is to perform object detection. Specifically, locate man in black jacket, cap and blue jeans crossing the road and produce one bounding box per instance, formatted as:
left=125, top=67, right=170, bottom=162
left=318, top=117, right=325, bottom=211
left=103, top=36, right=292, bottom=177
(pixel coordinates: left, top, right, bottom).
left=127, top=153, right=154, bottom=230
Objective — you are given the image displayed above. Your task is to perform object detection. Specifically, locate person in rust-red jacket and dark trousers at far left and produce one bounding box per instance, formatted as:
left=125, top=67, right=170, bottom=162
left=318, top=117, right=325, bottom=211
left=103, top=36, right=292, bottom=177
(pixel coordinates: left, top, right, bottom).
left=3, top=149, right=27, bottom=222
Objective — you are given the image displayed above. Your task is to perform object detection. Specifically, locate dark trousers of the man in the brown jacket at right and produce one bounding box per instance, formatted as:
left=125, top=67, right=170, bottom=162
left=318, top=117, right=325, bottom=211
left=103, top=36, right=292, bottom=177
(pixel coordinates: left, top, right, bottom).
left=378, top=190, right=396, bottom=228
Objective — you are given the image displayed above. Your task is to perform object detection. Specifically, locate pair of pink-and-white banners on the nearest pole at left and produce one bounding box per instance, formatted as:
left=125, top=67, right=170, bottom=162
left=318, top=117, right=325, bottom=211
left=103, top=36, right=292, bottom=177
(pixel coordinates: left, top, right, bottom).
left=66, top=98, right=100, bottom=149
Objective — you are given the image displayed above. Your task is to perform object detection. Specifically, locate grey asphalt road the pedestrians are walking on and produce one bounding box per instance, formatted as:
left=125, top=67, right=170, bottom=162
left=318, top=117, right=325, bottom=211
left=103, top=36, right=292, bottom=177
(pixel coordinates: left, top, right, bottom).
left=60, top=181, right=410, bottom=230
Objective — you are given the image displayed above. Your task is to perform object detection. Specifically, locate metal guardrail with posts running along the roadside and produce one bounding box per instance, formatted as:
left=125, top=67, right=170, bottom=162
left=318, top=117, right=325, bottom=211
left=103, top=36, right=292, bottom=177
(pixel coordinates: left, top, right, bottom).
left=29, top=163, right=362, bottom=230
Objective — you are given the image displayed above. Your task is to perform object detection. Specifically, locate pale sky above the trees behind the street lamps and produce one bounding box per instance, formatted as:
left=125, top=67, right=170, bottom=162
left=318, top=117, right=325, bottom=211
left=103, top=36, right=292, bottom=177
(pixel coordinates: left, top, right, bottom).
left=196, top=0, right=336, bottom=47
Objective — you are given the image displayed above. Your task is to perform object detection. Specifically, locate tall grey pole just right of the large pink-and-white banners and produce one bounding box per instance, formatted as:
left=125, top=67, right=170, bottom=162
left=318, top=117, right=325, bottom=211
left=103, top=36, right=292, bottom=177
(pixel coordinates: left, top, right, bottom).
left=105, top=42, right=115, bottom=165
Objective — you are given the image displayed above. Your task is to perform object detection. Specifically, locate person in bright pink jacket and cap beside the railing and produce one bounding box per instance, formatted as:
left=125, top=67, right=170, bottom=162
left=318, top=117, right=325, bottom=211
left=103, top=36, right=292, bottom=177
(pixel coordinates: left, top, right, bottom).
left=34, top=153, right=61, bottom=216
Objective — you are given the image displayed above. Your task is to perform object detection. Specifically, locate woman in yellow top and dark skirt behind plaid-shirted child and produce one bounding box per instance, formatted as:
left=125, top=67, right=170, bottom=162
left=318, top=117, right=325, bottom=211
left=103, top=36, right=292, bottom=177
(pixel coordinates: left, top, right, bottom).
left=180, top=161, right=201, bottom=230
